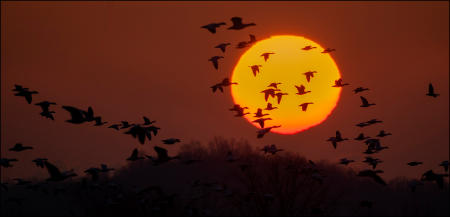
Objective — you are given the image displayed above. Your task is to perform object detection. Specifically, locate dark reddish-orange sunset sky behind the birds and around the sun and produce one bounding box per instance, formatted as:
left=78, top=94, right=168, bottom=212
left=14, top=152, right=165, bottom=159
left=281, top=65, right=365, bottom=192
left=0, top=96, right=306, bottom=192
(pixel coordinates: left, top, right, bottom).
left=1, top=1, right=449, bottom=179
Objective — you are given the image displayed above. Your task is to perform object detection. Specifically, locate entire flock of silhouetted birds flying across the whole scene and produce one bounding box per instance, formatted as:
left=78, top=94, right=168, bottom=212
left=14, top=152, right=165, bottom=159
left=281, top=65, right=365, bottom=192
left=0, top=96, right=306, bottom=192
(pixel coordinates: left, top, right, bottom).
left=0, top=17, right=448, bottom=191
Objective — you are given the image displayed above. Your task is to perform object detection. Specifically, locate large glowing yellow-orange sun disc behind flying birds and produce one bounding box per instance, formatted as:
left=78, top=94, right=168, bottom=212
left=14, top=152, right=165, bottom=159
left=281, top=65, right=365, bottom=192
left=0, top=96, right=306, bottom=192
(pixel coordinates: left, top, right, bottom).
left=231, top=35, right=342, bottom=134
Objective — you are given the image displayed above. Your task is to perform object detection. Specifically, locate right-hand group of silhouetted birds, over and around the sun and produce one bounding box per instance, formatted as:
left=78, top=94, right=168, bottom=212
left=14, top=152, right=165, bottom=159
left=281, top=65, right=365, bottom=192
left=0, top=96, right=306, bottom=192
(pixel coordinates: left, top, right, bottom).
left=202, top=17, right=448, bottom=189
